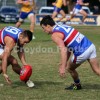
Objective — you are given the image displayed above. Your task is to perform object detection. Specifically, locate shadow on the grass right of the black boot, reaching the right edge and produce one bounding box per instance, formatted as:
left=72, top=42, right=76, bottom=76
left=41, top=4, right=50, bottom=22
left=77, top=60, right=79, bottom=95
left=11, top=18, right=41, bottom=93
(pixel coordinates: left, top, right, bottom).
left=82, top=83, right=100, bottom=90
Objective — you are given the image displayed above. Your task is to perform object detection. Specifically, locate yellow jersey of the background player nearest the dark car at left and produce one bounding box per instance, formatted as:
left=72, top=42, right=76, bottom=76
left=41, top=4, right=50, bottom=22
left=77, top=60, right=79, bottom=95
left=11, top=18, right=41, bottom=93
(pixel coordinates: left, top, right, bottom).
left=21, top=0, right=34, bottom=12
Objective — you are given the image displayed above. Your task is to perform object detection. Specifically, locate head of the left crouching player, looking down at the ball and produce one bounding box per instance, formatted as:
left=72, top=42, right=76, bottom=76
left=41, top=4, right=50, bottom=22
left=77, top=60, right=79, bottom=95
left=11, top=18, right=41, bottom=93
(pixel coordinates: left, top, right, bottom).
left=18, top=30, right=33, bottom=46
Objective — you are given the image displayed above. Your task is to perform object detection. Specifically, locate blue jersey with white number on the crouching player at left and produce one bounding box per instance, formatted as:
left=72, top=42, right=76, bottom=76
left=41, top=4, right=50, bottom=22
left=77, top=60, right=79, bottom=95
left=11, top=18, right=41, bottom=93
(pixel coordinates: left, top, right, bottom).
left=0, top=26, right=23, bottom=46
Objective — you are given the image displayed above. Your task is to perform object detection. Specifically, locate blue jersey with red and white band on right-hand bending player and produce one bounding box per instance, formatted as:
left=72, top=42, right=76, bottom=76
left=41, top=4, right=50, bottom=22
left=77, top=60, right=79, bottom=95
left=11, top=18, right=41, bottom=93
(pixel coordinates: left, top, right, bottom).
left=52, top=25, right=92, bottom=56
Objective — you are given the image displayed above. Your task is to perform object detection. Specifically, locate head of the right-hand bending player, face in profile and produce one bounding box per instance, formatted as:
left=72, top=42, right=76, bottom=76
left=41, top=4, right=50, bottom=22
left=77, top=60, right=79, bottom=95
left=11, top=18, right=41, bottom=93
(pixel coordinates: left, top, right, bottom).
left=40, top=15, right=55, bottom=33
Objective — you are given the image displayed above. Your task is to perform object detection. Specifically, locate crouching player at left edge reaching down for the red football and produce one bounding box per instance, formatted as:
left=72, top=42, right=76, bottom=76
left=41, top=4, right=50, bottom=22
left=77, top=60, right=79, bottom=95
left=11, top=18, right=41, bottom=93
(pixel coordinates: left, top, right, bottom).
left=0, top=26, right=34, bottom=87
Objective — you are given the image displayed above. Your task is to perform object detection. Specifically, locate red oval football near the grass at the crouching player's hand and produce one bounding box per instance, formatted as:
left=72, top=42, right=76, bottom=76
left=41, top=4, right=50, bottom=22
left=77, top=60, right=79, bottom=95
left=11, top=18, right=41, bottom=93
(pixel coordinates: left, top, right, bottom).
left=20, top=65, right=32, bottom=82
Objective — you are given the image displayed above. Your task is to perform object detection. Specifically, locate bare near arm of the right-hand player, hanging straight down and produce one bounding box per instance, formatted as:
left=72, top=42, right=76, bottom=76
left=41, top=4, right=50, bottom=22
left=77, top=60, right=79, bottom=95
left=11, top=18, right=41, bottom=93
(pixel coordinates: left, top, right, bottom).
left=52, top=32, right=67, bottom=77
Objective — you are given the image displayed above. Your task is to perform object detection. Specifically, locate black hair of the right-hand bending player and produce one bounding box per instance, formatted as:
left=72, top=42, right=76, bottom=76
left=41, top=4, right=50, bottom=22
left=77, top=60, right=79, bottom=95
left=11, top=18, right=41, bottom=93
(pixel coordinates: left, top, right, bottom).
left=40, top=15, right=55, bottom=26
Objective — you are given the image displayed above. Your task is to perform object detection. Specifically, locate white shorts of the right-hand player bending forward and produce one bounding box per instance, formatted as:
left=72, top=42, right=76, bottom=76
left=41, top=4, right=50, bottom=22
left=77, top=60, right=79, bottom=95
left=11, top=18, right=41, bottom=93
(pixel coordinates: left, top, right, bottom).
left=71, top=44, right=97, bottom=64
